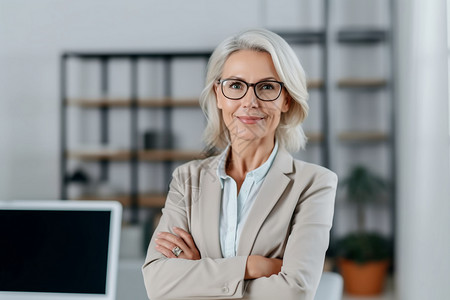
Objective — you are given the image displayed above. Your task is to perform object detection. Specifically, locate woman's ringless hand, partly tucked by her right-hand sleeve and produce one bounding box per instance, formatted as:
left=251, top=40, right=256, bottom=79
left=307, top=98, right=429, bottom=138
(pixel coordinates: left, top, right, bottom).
left=244, top=255, right=283, bottom=279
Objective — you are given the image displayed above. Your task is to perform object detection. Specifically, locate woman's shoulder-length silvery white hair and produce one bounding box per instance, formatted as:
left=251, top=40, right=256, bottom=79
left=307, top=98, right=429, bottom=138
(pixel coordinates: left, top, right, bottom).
left=200, top=29, right=309, bottom=152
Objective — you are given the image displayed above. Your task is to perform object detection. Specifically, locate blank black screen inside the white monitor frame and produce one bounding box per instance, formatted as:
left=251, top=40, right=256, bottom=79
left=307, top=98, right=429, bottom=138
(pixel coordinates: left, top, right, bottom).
left=0, top=210, right=111, bottom=294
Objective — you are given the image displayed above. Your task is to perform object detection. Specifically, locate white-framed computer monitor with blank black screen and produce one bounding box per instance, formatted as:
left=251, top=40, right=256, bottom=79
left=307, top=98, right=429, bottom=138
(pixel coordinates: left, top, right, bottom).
left=0, top=200, right=122, bottom=300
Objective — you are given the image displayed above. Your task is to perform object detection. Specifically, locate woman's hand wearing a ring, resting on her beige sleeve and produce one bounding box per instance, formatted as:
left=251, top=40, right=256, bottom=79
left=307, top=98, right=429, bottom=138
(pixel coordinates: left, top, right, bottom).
left=155, top=227, right=201, bottom=260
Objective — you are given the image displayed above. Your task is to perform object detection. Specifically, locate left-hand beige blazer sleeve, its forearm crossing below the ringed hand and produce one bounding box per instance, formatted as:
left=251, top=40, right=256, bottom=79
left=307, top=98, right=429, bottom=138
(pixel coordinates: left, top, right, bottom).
left=142, top=168, right=247, bottom=300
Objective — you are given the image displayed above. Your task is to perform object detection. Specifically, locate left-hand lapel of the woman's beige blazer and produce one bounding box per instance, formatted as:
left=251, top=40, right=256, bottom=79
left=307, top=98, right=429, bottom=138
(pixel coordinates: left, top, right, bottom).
left=200, top=158, right=222, bottom=258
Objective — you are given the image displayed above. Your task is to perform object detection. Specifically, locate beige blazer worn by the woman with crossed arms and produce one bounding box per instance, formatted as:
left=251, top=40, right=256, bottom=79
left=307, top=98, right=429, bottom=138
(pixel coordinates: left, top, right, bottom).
left=142, top=148, right=337, bottom=300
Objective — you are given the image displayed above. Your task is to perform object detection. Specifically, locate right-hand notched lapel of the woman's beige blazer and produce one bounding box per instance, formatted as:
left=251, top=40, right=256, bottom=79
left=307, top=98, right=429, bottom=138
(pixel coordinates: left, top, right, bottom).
left=236, top=148, right=293, bottom=256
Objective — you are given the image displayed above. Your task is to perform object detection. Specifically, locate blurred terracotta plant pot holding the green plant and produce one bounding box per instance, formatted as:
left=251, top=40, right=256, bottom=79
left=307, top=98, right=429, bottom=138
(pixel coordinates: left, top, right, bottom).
left=338, top=258, right=389, bottom=296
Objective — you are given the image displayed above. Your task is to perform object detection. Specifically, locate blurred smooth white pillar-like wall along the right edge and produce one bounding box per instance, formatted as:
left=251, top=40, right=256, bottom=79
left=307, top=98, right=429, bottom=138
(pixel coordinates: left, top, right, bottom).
left=396, top=0, right=450, bottom=300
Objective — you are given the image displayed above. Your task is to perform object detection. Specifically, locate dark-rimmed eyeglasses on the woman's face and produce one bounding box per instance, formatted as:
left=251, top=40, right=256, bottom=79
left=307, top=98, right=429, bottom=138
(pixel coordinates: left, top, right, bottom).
left=218, top=78, right=283, bottom=101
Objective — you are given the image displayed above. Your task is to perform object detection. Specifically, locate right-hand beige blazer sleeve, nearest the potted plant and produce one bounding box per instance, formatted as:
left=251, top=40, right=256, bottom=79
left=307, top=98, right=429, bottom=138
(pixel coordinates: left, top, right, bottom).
left=243, top=170, right=337, bottom=300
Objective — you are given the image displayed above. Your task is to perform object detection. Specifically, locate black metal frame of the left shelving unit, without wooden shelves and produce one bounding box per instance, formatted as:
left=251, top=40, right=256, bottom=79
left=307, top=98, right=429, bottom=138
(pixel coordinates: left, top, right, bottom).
left=60, top=51, right=211, bottom=222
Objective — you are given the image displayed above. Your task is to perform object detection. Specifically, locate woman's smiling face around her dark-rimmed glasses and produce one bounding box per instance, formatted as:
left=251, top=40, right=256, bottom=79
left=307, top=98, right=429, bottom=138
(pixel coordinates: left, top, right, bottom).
left=215, top=50, right=289, bottom=142
